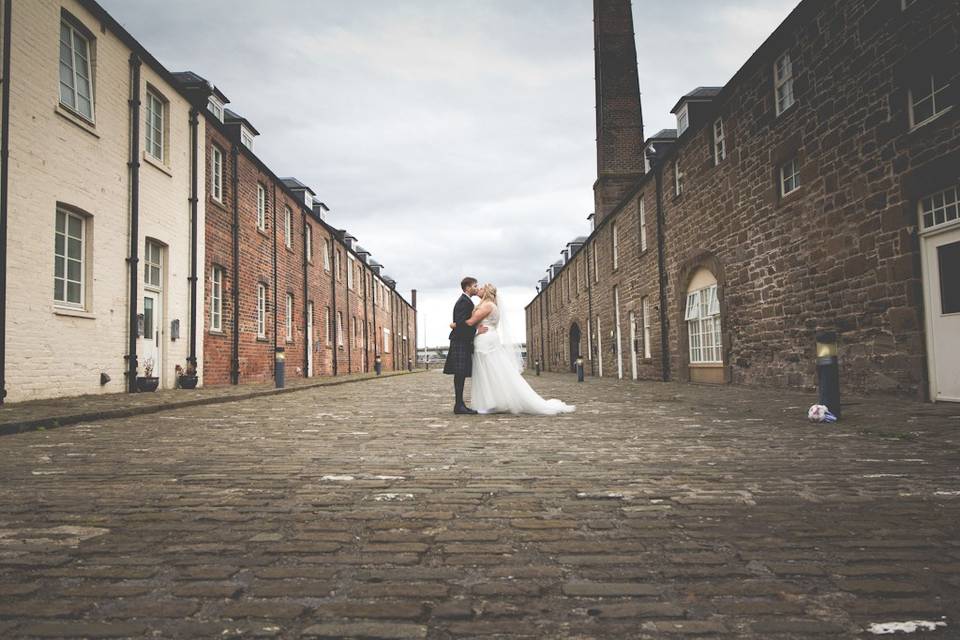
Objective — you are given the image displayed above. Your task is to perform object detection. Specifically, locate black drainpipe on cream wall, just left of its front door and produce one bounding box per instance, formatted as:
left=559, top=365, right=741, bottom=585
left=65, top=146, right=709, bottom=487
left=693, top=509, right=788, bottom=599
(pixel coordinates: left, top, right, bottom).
left=125, top=53, right=141, bottom=393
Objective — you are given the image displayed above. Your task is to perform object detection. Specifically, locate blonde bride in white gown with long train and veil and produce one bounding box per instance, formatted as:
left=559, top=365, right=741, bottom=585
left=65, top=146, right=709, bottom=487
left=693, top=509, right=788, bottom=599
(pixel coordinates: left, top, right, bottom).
left=451, top=284, right=576, bottom=416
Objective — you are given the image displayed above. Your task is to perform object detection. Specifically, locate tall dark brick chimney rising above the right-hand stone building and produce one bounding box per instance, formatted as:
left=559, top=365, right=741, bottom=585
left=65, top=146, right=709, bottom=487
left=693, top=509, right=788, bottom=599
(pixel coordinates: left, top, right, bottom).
left=593, top=0, right=643, bottom=224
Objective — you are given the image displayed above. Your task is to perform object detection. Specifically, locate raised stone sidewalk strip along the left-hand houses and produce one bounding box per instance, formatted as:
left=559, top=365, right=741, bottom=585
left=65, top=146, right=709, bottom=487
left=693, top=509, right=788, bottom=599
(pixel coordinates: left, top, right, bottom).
left=0, top=370, right=421, bottom=435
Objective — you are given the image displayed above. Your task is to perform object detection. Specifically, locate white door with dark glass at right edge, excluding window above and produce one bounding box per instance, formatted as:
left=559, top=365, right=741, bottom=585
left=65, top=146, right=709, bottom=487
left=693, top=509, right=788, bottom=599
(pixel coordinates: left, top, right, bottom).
left=923, top=225, right=960, bottom=402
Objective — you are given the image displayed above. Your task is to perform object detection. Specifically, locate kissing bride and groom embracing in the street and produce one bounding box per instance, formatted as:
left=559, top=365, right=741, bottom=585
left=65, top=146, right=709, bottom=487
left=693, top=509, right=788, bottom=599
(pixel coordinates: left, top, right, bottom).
left=443, top=278, right=576, bottom=415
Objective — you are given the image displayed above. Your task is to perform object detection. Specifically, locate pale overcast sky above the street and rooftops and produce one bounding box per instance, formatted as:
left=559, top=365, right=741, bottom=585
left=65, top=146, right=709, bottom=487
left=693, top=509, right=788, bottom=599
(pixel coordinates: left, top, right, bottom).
left=100, top=0, right=796, bottom=346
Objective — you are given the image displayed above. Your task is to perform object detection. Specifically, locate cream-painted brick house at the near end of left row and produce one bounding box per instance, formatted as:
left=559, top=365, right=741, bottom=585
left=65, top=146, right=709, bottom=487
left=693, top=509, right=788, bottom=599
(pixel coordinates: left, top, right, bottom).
left=0, top=0, right=206, bottom=402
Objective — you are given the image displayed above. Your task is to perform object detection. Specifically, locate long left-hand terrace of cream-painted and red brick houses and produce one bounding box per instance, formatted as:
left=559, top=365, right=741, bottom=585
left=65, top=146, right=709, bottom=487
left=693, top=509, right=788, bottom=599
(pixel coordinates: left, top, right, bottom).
left=0, top=0, right=416, bottom=403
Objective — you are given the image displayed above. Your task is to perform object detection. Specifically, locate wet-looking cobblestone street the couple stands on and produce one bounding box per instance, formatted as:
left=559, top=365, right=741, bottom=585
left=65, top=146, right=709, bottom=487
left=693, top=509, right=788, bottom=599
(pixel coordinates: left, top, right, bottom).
left=0, top=372, right=960, bottom=640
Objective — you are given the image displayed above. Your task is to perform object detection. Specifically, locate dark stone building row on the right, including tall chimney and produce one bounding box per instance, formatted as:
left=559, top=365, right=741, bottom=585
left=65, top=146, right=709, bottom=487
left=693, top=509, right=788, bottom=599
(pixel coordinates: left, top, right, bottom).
left=527, top=0, right=960, bottom=401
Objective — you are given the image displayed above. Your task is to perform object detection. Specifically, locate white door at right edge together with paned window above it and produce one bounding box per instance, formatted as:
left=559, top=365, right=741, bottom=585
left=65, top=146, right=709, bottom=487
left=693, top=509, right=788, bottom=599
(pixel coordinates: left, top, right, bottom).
left=920, top=187, right=960, bottom=402
